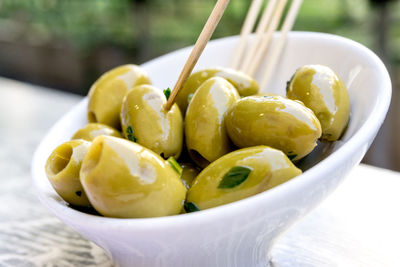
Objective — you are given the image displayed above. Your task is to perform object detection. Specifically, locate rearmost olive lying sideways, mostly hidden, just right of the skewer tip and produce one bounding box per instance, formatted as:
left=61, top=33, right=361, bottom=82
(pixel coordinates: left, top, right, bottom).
left=176, top=67, right=259, bottom=114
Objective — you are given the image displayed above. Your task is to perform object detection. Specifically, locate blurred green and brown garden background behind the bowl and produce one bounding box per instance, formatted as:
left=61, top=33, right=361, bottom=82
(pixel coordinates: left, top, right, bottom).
left=0, top=0, right=400, bottom=170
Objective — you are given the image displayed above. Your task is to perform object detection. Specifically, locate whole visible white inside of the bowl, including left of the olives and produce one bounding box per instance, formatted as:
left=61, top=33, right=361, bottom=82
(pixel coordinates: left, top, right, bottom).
left=32, top=32, right=391, bottom=222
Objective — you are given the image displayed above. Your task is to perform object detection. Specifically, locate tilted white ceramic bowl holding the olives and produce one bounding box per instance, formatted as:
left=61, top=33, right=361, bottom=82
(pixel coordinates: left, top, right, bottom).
left=32, top=32, right=391, bottom=267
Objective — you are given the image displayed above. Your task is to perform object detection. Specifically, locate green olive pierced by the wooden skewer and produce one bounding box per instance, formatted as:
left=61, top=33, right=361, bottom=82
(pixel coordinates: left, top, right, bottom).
left=121, top=85, right=183, bottom=159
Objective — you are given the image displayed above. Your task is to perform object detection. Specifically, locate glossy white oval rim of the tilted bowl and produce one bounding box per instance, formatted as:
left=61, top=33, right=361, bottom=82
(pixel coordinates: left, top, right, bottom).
left=31, top=31, right=392, bottom=231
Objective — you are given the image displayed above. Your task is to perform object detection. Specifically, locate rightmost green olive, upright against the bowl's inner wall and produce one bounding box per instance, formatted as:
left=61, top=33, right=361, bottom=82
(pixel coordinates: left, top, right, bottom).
left=286, top=65, right=350, bottom=141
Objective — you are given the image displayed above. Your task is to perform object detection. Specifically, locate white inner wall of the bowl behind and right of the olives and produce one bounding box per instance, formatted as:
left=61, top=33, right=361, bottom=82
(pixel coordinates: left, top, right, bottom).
left=143, top=32, right=386, bottom=171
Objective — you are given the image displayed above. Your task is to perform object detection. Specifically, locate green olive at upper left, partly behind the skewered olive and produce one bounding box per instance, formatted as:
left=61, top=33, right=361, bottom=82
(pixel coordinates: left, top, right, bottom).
left=88, top=65, right=150, bottom=129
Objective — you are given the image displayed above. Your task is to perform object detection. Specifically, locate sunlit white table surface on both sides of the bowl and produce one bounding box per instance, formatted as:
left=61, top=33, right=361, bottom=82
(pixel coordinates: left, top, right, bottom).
left=0, top=78, right=400, bottom=267
